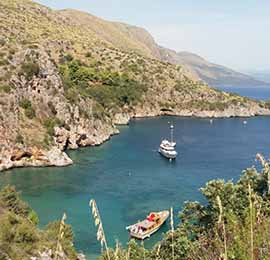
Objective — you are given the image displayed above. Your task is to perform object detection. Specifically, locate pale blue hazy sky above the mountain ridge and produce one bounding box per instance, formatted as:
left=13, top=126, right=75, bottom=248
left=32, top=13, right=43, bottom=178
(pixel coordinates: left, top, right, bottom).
left=37, top=0, right=270, bottom=72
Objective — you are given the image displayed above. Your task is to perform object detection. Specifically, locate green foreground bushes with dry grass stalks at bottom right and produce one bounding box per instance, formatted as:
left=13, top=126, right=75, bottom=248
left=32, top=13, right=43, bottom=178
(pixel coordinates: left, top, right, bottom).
left=100, top=155, right=270, bottom=260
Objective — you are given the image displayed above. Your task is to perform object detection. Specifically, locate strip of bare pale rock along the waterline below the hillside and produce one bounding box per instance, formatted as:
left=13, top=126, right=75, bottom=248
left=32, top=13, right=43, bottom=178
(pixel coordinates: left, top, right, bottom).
left=0, top=103, right=270, bottom=172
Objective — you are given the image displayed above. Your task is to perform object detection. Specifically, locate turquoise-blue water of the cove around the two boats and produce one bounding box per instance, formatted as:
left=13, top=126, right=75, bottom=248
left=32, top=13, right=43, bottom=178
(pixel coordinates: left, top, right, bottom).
left=0, top=117, right=270, bottom=260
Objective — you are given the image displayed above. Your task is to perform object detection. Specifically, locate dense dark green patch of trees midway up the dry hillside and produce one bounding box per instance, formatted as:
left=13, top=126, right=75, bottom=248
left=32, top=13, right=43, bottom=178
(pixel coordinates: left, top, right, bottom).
left=60, top=60, right=146, bottom=114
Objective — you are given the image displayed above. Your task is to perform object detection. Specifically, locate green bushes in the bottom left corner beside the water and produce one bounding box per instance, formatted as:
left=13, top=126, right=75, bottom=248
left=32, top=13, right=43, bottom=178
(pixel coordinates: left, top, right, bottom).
left=0, top=186, right=77, bottom=260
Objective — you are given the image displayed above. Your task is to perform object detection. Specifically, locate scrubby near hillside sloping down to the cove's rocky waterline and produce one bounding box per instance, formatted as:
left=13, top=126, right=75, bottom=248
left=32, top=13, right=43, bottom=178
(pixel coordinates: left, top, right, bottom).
left=0, top=0, right=270, bottom=170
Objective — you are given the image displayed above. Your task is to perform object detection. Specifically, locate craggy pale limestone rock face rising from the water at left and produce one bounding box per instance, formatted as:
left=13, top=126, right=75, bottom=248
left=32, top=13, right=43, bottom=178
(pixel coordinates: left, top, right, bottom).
left=0, top=48, right=118, bottom=171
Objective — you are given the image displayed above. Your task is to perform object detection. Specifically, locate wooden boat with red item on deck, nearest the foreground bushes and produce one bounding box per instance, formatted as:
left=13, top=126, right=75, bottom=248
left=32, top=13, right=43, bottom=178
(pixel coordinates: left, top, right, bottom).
left=126, top=210, right=170, bottom=240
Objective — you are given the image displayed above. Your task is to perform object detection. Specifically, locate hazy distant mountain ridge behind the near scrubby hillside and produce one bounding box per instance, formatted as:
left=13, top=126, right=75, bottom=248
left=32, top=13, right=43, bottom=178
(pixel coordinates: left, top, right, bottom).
left=59, top=10, right=267, bottom=87
